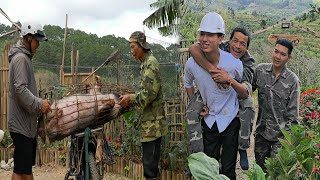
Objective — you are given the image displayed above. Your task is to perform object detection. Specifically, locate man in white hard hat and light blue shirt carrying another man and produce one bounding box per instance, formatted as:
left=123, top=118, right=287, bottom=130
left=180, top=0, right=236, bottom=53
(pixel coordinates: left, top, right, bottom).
left=184, top=12, right=247, bottom=180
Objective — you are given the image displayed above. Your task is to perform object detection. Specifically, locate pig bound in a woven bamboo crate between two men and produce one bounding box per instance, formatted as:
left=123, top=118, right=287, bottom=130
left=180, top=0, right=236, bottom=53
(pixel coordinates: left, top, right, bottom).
left=38, top=94, right=123, bottom=142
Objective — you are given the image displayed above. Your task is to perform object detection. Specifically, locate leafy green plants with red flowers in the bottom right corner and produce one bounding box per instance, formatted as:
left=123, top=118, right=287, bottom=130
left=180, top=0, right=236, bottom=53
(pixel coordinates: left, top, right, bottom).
left=247, top=88, right=320, bottom=180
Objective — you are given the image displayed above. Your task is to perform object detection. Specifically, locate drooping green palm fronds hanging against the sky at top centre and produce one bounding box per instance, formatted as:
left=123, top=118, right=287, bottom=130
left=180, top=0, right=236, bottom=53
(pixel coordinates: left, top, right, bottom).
left=143, top=0, right=186, bottom=36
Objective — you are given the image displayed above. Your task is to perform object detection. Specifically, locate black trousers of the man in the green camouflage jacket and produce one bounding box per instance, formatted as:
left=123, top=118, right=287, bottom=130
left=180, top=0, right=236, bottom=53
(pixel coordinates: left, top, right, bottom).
left=142, top=137, right=161, bottom=180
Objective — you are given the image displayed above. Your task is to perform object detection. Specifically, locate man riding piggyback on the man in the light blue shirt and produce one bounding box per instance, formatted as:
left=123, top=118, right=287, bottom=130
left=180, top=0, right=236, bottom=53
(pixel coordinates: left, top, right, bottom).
left=186, top=27, right=255, bottom=170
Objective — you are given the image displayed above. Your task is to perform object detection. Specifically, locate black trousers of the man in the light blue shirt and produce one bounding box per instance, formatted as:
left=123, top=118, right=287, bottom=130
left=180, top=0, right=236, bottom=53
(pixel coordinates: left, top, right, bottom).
left=201, top=117, right=240, bottom=180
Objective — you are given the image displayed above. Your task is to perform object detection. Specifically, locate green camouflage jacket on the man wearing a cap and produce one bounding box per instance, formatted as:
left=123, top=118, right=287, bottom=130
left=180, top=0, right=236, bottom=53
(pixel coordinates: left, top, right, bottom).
left=130, top=54, right=168, bottom=142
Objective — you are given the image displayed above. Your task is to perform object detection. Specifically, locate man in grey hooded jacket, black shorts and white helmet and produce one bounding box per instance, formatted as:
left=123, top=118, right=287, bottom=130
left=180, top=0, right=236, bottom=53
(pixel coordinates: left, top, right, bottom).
left=8, top=23, right=51, bottom=180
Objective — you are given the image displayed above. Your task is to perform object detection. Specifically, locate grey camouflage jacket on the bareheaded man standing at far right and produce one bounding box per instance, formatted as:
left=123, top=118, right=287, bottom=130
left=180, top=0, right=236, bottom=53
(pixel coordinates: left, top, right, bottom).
left=252, top=63, right=300, bottom=141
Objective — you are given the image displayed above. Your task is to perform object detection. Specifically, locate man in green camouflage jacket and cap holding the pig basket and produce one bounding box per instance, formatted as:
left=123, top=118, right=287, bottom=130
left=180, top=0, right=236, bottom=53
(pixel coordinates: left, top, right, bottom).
left=120, top=31, right=168, bottom=180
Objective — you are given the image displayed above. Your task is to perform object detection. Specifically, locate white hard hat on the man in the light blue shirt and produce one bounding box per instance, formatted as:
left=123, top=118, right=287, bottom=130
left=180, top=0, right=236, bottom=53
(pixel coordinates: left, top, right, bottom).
left=198, top=12, right=225, bottom=34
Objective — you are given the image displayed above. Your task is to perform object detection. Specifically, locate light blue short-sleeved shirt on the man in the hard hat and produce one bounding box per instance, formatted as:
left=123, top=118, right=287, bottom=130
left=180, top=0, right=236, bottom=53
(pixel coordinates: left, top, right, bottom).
left=184, top=50, right=243, bottom=133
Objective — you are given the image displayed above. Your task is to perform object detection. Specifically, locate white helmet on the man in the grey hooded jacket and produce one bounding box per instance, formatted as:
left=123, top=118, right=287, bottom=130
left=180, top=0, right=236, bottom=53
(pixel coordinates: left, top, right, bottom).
left=21, top=22, right=48, bottom=41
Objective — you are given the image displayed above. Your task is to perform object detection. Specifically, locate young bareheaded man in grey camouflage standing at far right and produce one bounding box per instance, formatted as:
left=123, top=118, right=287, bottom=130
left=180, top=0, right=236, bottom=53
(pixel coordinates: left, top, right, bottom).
left=252, top=39, right=300, bottom=170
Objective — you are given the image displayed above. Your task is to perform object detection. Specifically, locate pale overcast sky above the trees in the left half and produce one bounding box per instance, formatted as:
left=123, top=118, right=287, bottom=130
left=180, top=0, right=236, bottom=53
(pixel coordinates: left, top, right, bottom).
left=0, top=0, right=177, bottom=46
